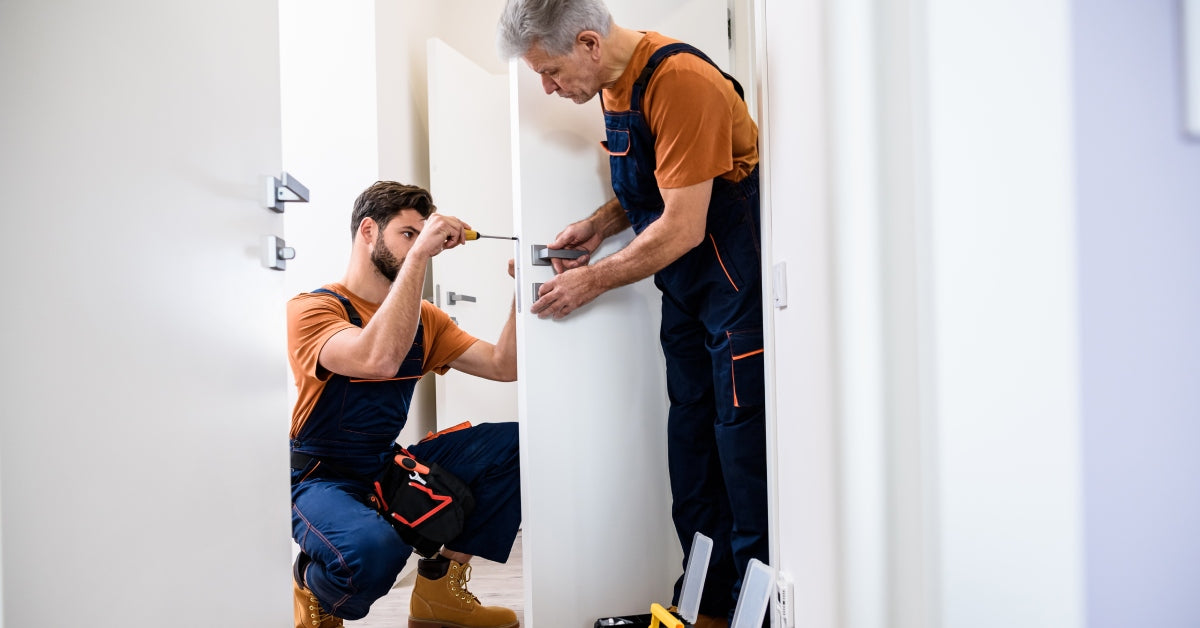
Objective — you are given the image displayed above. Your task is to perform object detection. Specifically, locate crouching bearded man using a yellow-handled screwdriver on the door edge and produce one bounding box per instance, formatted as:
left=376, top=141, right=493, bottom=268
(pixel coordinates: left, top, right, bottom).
left=288, top=181, right=521, bottom=628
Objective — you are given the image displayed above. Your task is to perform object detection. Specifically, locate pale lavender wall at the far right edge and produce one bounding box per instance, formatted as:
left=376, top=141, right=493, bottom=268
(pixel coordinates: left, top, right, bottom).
left=1074, top=0, right=1200, bottom=628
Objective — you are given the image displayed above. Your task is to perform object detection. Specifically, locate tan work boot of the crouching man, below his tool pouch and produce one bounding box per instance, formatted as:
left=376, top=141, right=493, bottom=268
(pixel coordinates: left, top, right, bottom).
left=408, top=556, right=517, bottom=628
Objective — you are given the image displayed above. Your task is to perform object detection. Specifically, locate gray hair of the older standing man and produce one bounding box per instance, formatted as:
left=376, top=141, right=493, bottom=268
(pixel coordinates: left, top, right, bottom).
left=497, top=0, right=612, bottom=59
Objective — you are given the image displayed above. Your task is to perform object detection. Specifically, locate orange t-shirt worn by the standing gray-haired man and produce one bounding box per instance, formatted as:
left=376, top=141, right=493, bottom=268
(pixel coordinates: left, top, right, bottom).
left=601, top=31, right=758, bottom=189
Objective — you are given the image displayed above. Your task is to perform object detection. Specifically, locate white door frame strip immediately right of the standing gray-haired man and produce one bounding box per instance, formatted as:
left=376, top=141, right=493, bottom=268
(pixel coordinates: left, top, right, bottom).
left=757, top=0, right=841, bottom=626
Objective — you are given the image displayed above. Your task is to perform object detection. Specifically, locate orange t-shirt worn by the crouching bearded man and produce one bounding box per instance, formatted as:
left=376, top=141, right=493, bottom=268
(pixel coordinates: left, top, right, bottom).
left=288, top=283, right=479, bottom=438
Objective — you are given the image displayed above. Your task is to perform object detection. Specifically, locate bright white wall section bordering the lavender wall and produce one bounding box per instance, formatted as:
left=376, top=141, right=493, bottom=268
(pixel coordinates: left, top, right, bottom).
left=926, top=0, right=1082, bottom=628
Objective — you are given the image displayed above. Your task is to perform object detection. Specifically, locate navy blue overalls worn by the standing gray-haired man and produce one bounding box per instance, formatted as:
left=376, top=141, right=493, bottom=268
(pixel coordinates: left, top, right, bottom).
left=601, top=43, right=768, bottom=616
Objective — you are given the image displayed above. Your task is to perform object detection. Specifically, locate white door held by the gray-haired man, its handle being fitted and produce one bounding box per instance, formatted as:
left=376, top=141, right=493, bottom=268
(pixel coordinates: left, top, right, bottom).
left=510, top=0, right=728, bottom=628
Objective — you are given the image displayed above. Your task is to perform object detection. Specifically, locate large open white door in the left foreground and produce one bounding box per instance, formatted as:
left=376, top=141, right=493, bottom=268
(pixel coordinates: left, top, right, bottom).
left=0, top=0, right=292, bottom=628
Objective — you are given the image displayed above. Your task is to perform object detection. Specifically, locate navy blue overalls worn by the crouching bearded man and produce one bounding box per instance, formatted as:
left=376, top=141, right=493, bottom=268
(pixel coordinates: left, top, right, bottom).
left=292, top=288, right=521, bottom=620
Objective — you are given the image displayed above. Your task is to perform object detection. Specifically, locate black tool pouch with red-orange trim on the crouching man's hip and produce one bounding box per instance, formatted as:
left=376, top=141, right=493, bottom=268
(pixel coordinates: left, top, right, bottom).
left=371, top=449, right=475, bottom=558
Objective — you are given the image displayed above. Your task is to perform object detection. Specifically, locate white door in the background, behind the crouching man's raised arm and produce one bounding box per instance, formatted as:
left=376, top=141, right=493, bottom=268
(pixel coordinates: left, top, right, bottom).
left=428, top=38, right=520, bottom=429
